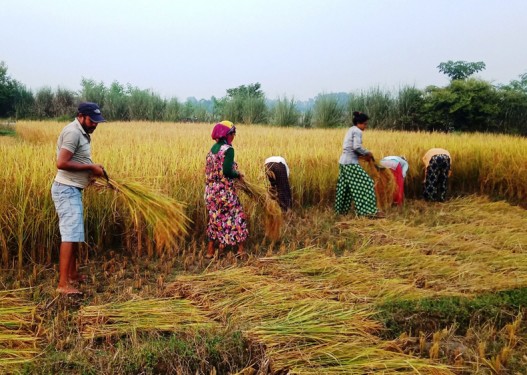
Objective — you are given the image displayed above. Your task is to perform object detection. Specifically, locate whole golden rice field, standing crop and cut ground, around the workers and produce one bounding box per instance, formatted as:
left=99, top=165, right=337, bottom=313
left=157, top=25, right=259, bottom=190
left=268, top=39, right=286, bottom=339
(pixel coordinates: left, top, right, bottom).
left=0, top=122, right=527, bottom=374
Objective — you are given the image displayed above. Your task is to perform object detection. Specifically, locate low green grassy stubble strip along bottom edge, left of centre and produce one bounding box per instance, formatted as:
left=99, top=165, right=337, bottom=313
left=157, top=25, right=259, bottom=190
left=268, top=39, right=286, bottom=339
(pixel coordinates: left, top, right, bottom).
left=20, top=331, right=255, bottom=374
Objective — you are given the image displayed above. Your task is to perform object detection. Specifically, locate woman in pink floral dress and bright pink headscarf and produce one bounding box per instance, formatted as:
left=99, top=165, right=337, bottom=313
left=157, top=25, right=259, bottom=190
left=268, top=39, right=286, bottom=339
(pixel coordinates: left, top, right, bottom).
left=205, top=121, right=248, bottom=259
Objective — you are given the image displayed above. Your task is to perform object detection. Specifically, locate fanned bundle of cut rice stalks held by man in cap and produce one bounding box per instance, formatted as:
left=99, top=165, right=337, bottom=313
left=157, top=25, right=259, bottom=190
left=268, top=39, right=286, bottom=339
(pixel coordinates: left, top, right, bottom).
left=95, top=176, right=191, bottom=254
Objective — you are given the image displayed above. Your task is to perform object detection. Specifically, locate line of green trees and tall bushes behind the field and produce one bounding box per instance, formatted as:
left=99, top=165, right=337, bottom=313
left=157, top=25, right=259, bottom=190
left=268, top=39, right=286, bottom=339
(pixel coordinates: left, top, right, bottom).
left=0, top=61, right=527, bottom=135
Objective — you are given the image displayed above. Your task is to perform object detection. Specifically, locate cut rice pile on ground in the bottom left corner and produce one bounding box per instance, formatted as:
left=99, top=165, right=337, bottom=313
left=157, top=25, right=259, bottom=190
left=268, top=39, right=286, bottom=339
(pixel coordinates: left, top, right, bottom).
left=0, top=291, right=40, bottom=373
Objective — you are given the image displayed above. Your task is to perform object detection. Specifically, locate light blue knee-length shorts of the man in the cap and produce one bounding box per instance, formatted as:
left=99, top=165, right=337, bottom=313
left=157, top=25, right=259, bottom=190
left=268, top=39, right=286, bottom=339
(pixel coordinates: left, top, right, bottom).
left=51, top=181, right=84, bottom=242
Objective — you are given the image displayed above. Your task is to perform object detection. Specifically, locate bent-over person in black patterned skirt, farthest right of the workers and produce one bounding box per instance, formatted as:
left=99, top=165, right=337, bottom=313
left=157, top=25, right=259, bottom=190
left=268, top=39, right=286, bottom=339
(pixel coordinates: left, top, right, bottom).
left=423, top=148, right=452, bottom=202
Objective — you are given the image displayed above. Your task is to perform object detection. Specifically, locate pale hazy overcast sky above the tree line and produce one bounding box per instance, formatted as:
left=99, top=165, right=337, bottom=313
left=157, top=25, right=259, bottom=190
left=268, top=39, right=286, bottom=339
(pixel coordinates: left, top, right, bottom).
left=0, top=0, right=527, bottom=100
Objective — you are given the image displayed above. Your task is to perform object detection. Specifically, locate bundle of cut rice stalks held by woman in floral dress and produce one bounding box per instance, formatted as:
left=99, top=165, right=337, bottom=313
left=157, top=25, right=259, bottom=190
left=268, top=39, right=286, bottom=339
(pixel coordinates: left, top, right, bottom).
left=238, top=178, right=283, bottom=241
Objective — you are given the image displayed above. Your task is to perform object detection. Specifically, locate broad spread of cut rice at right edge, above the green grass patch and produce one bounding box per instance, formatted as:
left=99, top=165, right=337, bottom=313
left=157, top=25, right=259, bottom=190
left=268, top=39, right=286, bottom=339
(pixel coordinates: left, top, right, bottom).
left=340, top=196, right=527, bottom=295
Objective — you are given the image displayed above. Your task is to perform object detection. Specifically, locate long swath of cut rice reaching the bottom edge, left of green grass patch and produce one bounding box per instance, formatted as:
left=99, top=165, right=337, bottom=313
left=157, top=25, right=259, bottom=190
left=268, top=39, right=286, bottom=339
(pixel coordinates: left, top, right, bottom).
left=168, top=264, right=450, bottom=374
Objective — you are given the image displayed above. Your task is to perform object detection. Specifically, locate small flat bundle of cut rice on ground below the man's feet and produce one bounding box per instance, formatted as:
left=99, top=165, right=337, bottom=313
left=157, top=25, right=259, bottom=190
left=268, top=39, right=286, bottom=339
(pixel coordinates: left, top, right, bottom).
left=79, top=298, right=212, bottom=339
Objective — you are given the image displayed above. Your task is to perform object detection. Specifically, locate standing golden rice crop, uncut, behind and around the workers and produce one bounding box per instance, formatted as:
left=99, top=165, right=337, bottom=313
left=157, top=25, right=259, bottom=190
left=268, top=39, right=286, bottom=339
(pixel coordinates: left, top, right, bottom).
left=0, top=122, right=527, bottom=267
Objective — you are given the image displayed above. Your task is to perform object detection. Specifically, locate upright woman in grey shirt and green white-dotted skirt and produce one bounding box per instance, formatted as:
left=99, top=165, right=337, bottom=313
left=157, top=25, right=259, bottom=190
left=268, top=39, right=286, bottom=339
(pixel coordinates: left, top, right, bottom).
left=335, top=112, right=384, bottom=218
